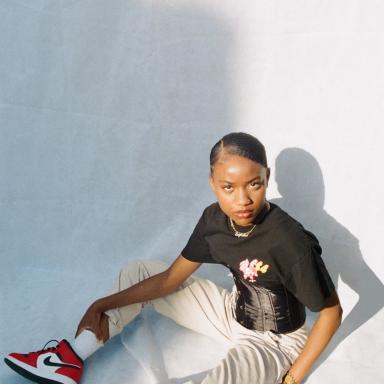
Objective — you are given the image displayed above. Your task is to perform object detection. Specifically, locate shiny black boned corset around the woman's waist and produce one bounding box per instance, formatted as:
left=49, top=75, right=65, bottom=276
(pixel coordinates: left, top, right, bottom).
left=235, top=278, right=305, bottom=333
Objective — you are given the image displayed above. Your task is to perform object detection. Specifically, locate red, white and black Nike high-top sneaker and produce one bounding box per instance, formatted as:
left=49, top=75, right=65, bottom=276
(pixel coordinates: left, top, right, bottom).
left=4, top=340, right=84, bottom=384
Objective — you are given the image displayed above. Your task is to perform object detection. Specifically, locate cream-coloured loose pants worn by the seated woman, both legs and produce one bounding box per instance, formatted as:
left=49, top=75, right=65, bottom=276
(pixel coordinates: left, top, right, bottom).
left=106, top=262, right=307, bottom=384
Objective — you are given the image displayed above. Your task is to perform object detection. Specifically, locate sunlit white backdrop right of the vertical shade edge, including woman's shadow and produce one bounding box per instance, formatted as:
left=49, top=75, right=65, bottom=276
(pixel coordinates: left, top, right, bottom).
left=225, top=1, right=384, bottom=383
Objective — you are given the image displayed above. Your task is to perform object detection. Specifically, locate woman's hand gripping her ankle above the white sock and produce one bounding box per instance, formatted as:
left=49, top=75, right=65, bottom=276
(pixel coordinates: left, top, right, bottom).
left=75, top=302, right=109, bottom=343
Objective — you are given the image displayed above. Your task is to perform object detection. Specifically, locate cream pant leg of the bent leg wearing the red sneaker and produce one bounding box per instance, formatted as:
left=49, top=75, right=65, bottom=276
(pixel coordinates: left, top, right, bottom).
left=106, top=261, right=237, bottom=341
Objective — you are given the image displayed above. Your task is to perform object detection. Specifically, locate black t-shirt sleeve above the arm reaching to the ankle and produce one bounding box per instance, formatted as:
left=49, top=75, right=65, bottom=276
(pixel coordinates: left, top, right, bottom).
left=181, top=208, right=214, bottom=263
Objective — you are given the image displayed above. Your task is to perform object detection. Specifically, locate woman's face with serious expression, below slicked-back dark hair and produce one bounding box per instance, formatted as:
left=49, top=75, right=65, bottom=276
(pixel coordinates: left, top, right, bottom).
left=209, top=150, right=269, bottom=226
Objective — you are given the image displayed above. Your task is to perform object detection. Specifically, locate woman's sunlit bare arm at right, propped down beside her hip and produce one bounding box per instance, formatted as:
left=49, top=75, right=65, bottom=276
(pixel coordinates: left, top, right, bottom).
left=283, top=291, right=343, bottom=384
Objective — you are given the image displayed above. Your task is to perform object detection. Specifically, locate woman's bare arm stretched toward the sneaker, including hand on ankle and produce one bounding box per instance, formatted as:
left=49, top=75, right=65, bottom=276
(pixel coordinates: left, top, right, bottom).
left=76, top=255, right=201, bottom=342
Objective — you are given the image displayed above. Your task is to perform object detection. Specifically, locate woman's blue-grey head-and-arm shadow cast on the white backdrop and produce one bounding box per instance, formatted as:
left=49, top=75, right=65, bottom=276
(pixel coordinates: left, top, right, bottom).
left=273, top=148, right=384, bottom=378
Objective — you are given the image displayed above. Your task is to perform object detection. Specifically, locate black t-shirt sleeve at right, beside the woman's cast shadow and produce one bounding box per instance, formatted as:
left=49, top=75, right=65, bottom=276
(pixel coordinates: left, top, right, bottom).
left=285, top=243, right=335, bottom=312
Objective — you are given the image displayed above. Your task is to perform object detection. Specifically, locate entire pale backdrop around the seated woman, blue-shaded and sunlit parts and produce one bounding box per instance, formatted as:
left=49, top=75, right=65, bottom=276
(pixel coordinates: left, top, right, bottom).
left=0, top=0, right=384, bottom=384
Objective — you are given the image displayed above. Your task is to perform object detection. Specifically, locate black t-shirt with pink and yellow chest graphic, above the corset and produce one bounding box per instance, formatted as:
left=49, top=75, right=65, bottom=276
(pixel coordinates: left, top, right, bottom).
left=181, top=203, right=335, bottom=318
